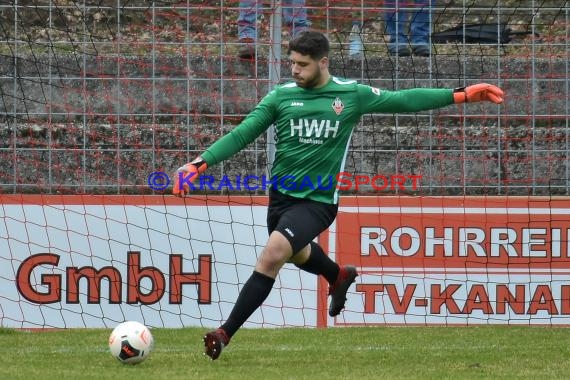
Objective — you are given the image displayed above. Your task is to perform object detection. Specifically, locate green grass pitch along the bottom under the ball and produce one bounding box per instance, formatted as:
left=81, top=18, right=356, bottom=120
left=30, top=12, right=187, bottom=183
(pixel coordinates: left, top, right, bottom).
left=0, top=326, right=570, bottom=380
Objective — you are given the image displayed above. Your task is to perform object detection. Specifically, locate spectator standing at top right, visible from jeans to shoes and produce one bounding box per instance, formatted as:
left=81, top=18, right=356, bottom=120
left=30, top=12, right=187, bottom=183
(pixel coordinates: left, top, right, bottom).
left=384, top=0, right=428, bottom=57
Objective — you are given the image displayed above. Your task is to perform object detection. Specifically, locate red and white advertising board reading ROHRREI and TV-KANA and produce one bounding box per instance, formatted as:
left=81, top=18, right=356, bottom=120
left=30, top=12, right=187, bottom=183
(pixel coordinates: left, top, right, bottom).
left=319, top=196, right=570, bottom=325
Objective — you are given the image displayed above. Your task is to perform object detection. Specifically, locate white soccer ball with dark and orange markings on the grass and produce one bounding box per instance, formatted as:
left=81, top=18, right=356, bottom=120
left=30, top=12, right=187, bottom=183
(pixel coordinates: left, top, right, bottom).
left=109, top=321, right=154, bottom=364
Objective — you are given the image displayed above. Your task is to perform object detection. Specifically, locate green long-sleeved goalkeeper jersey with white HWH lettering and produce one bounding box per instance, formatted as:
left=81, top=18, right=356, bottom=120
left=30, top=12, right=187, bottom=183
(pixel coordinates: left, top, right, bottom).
left=202, top=77, right=453, bottom=204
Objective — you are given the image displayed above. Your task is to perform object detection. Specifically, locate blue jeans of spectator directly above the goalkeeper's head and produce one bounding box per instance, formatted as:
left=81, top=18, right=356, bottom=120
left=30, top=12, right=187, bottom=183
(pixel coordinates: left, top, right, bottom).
left=238, top=0, right=310, bottom=41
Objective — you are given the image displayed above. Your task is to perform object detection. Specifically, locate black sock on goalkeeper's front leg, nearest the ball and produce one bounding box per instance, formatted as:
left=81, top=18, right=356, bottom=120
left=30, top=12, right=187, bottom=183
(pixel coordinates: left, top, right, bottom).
left=221, top=271, right=275, bottom=338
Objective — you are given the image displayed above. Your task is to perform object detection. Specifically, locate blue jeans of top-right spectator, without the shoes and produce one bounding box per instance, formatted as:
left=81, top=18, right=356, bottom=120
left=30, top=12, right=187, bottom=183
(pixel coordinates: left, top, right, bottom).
left=384, top=0, right=432, bottom=51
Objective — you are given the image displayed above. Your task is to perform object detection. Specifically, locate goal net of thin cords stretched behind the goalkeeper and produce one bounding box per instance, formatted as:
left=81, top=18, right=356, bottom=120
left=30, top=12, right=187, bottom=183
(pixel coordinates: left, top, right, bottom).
left=0, top=0, right=570, bottom=328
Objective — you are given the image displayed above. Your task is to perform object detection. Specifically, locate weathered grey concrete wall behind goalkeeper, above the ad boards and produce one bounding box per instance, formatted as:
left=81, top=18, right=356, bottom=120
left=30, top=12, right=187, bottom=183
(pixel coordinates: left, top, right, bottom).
left=0, top=56, right=569, bottom=195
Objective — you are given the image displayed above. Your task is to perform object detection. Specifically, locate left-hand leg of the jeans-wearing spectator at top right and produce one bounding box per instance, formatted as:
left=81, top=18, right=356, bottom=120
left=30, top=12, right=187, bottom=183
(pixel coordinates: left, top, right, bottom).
left=384, top=0, right=410, bottom=57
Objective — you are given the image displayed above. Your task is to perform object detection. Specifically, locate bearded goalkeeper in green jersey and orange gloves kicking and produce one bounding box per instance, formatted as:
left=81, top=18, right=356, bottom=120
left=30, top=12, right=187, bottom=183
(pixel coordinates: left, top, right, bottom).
left=173, top=31, right=503, bottom=359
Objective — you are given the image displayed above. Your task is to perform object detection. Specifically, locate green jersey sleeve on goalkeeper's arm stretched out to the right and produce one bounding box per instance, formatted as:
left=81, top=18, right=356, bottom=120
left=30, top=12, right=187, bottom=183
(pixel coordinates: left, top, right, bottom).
left=357, top=84, right=453, bottom=114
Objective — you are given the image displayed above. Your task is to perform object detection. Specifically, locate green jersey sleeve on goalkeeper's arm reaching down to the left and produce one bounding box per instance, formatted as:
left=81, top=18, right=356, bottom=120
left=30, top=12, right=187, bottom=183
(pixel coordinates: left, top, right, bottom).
left=201, top=90, right=277, bottom=166
